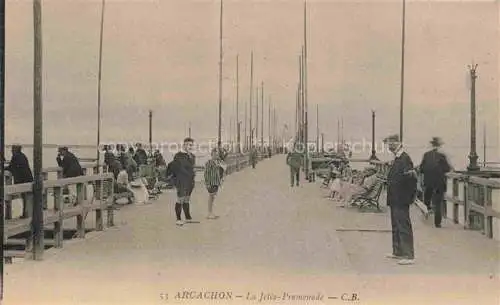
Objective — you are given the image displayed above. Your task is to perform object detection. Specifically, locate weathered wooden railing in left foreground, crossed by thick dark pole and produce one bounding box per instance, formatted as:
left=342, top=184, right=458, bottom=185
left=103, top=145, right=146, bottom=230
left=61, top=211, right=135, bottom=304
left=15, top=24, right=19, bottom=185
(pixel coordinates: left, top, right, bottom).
left=4, top=173, right=114, bottom=258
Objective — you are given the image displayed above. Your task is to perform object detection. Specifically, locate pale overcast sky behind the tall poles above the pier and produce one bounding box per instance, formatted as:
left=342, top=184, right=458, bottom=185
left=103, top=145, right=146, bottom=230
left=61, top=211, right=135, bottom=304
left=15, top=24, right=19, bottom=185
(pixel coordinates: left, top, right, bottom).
left=6, top=0, right=500, bottom=151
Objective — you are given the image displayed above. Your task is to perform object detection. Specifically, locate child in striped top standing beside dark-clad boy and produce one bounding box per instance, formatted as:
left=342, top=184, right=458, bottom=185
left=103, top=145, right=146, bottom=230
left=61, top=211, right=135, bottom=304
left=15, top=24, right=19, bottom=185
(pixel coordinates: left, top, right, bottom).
left=204, top=149, right=224, bottom=219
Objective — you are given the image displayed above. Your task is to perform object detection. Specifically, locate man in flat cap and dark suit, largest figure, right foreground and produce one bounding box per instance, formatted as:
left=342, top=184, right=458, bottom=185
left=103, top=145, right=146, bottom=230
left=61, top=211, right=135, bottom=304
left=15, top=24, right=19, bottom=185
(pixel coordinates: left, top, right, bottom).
left=384, top=135, right=417, bottom=265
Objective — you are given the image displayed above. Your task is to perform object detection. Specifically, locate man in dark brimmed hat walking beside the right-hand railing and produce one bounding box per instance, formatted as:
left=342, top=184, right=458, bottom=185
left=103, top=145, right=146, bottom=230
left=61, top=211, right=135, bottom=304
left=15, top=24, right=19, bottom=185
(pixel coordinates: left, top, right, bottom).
left=419, top=137, right=451, bottom=228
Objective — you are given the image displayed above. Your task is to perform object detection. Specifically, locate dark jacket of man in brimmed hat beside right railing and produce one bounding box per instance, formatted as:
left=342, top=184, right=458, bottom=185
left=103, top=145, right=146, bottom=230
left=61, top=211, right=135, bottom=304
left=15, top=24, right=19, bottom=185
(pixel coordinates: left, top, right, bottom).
left=419, top=149, right=451, bottom=190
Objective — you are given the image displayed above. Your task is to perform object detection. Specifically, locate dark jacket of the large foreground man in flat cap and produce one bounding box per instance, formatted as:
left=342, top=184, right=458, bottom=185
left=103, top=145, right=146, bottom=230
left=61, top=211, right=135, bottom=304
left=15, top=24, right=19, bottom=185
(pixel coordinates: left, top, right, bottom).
left=387, top=152, right=417, bottom=206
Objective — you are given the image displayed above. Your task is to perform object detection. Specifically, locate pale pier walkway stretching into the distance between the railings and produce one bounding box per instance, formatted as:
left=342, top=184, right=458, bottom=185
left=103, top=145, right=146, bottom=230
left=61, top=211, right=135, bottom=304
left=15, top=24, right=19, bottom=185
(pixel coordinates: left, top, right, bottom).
left=3, top=155, right=500, bottom=305
